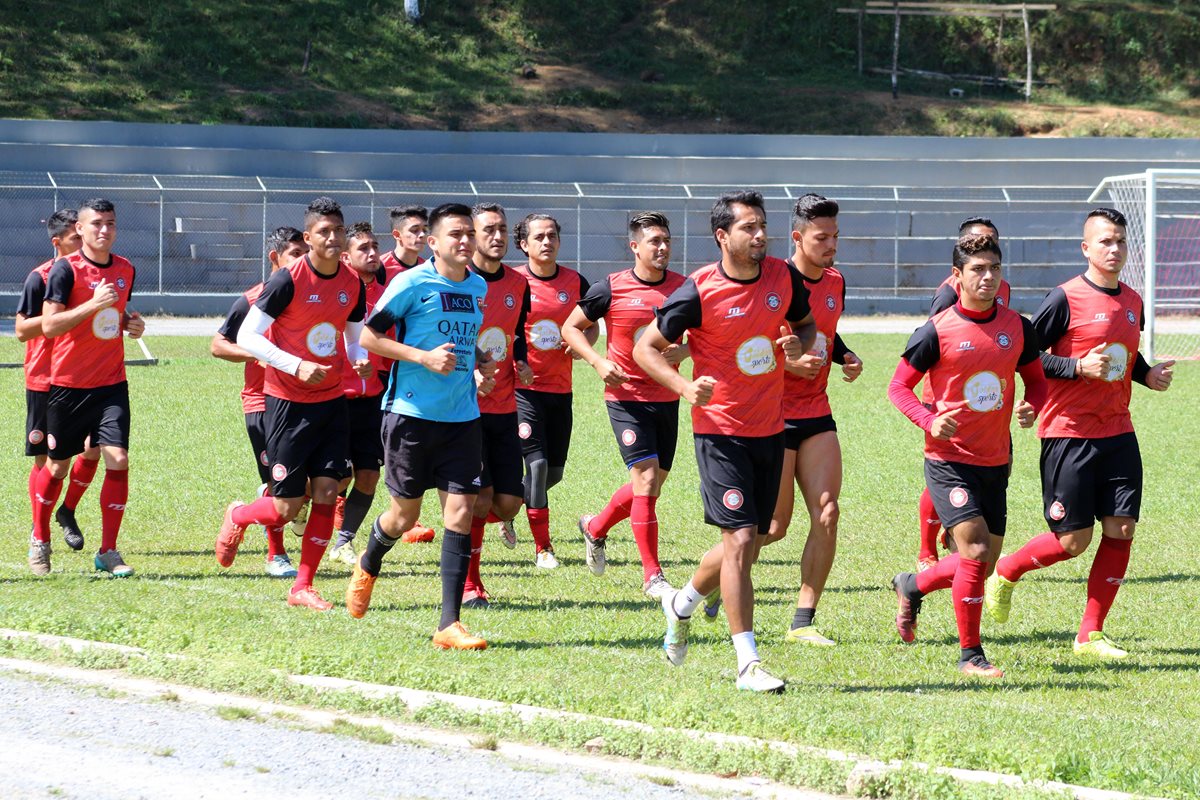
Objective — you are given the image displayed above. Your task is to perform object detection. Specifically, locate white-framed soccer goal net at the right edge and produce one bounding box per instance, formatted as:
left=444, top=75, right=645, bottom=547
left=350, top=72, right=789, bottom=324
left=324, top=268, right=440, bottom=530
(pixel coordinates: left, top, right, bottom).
left=1088, top=169, right=1200, bottom=361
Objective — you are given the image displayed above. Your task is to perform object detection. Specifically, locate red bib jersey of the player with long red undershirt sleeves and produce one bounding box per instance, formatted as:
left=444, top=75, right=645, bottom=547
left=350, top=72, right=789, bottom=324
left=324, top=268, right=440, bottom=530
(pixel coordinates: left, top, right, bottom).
left=904, top=305, right=1039, bottom=467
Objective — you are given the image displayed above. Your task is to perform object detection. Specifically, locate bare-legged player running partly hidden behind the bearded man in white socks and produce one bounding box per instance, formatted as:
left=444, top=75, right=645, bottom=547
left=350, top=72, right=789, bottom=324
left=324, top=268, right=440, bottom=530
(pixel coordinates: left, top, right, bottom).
left=762, top=194, right=863, bottom=646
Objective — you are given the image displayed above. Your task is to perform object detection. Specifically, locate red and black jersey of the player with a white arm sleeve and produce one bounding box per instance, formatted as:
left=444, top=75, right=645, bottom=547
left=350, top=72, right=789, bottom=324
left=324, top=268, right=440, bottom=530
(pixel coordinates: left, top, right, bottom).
left=254, top=255, right=366, bottom=403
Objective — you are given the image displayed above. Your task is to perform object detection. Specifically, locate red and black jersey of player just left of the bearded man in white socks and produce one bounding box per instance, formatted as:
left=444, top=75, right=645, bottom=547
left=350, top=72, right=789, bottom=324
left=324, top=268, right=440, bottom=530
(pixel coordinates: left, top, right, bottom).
left=580, top=270, right=685, bottom=403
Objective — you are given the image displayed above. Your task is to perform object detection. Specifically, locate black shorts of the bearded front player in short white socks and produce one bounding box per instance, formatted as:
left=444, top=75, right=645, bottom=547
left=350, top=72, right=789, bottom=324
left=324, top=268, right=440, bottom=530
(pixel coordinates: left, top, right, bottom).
left=696, top=433, right=784, bottom=536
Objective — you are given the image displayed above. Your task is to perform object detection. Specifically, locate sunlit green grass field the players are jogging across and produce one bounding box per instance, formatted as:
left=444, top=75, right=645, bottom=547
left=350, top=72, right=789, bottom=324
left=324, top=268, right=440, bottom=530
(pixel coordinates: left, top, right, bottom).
left=0, top=335, right=1200, bottom=798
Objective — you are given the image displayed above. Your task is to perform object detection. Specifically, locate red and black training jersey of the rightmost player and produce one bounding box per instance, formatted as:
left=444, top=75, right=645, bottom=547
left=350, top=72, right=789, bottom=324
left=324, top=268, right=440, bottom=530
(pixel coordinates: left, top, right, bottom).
left=1033, top=275, right=1145, bottom=439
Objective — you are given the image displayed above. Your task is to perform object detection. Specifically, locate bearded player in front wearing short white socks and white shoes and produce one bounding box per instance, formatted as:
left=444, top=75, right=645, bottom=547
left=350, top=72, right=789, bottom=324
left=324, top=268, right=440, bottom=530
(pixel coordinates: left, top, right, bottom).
left=634, top=191, right=816, bottom=692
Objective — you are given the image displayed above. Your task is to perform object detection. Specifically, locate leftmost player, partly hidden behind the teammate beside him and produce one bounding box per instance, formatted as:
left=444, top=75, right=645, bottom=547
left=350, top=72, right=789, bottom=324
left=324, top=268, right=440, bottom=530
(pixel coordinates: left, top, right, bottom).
left=16, top=209, right=100, bottom=575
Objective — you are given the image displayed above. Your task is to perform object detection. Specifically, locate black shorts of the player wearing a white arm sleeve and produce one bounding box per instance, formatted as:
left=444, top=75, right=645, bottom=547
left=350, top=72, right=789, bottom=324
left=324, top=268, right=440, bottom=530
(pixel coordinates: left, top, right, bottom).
left=266, top=395, right=350, bottom=498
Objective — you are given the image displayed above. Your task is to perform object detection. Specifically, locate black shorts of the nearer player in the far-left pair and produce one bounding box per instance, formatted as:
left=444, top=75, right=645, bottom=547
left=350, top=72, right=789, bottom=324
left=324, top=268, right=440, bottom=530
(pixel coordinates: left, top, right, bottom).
left=46, top=380, right=130, bottom=461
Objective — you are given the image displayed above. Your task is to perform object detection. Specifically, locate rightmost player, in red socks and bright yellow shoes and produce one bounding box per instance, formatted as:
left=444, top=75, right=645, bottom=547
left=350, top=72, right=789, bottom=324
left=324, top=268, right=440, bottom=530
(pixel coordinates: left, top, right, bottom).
left=986, top=209, right=1175, bottom=660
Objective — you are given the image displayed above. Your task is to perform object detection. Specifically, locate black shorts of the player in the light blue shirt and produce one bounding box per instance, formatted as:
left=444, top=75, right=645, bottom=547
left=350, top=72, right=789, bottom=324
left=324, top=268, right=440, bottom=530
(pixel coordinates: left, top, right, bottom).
left=383, top=411, right=482, bottom=500
